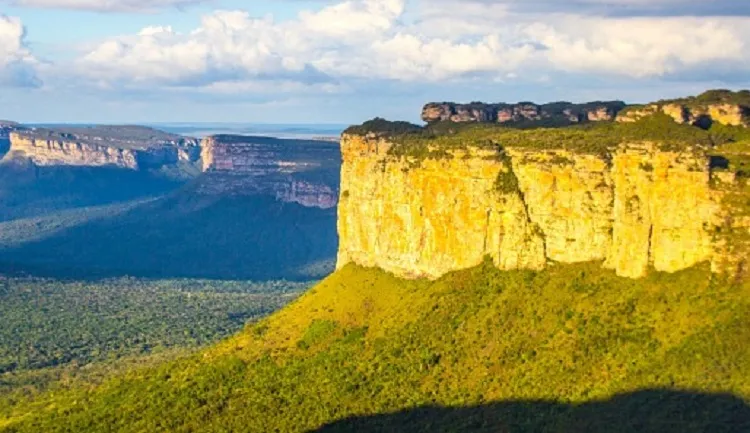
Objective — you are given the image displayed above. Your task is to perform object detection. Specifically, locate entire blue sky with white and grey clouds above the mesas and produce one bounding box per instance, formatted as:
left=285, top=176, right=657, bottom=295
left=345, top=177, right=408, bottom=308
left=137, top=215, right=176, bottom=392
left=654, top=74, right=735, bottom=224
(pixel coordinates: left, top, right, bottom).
left=0, top=0, right=750, bottom=124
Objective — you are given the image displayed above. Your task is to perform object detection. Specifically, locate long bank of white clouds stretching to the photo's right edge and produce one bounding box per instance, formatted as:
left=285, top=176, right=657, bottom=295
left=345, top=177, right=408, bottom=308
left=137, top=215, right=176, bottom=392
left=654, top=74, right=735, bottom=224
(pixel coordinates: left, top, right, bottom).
left=63, top=0, right=750, bottom=93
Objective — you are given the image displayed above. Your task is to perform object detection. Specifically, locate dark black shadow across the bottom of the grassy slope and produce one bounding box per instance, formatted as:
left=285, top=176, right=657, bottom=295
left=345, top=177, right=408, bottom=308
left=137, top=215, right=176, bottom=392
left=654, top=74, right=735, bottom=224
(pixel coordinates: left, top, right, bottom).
left=318, top=390, right=750, bottom=433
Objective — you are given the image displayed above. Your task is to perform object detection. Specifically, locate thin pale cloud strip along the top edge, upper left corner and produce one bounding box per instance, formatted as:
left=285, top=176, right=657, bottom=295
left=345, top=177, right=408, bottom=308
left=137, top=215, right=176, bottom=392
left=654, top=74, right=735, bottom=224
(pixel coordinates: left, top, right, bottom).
left=0, top=0, right=211, bottom=12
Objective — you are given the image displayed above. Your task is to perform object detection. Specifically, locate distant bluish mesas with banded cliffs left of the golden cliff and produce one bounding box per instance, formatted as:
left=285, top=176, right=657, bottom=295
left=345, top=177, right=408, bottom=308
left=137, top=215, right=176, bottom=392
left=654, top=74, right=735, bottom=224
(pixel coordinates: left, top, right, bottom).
left=0, top=122, right=341, bottom=209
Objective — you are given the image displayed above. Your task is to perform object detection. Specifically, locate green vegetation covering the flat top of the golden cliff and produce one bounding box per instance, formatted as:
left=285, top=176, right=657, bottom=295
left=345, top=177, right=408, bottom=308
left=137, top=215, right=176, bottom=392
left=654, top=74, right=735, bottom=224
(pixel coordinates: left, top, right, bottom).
left=344, top=90, right=750, bottom=157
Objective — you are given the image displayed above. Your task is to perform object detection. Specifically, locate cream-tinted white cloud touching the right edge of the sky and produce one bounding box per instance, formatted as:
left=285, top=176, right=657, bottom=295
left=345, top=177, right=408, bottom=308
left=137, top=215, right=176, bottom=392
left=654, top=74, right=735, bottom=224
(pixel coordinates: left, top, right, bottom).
left=527, top=17, right=750, bottom=77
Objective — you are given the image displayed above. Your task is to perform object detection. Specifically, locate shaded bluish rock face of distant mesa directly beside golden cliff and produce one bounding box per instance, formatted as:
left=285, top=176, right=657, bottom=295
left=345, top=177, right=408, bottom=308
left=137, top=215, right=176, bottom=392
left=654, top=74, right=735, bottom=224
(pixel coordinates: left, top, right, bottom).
left=198, top=135, right=341, bottom=209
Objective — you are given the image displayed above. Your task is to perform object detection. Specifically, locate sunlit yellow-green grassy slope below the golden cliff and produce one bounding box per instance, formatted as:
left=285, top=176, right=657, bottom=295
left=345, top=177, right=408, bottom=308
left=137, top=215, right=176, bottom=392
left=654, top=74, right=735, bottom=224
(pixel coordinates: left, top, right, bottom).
left=0, top=263, right=750, bottom=432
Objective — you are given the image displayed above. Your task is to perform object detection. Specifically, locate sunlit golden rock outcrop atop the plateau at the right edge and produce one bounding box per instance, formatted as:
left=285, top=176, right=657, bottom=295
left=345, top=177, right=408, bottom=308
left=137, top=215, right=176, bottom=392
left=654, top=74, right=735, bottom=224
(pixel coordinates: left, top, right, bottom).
left=617, top=90, right=750, bottom=129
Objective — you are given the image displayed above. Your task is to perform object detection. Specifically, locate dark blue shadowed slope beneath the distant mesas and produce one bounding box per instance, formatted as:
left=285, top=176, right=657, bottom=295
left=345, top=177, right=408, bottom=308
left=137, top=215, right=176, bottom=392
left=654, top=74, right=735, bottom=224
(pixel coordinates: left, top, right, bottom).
left=0, top=188, right=338, bottom=281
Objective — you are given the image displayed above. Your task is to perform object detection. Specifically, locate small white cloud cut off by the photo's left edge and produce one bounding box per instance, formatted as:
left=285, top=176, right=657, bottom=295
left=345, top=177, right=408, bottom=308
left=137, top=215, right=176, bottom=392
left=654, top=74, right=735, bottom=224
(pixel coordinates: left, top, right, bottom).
left=0, top=15, right=40, bottom=86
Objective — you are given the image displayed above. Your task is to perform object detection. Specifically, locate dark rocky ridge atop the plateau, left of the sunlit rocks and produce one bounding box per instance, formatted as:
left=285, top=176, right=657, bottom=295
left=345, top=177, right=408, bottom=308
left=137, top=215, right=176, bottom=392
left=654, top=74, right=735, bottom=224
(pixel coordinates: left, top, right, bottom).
left=422, top=101, right=625, bottom=125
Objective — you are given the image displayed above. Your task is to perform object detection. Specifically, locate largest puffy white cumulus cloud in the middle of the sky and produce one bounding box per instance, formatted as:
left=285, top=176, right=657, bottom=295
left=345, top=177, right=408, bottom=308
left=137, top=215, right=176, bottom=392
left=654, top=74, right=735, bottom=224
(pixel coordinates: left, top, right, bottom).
left=79, top=0, right=530, bottom=85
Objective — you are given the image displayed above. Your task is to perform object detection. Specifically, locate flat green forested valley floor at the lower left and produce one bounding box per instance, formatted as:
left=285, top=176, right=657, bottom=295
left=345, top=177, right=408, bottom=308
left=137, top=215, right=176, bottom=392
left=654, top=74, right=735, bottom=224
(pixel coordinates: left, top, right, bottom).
left=0, top=278, right=308, bottom=374
